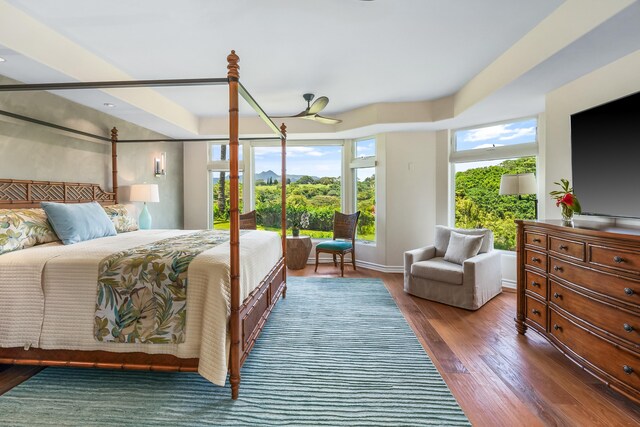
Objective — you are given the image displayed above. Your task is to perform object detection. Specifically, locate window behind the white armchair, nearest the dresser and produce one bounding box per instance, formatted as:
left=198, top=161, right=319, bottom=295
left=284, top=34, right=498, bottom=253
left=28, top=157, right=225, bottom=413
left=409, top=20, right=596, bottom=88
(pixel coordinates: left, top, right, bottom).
left=451, top=119, right=537, bottom=251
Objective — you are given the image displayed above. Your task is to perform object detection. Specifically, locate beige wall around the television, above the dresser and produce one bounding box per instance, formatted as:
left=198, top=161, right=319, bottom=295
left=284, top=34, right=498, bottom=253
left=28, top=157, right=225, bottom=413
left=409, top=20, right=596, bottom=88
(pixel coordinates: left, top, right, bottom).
left=539, top=50, right=640, bottom=218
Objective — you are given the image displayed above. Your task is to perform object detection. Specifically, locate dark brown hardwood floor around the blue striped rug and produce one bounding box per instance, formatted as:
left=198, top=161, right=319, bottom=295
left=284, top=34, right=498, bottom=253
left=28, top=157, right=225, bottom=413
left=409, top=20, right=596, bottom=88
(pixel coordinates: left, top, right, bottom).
left=0, top=264, right=640, bottom=427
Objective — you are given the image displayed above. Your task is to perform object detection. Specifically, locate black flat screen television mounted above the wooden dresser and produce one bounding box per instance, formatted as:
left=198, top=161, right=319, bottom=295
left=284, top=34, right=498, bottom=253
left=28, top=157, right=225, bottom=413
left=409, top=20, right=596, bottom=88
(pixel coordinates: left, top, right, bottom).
left=571, top=92, right=640, bottom=218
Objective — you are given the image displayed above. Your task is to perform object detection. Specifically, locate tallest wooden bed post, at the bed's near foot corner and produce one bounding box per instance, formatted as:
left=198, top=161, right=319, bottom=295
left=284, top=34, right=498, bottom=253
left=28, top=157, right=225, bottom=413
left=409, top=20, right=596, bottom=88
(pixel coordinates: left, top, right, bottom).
left=227, top=50, right=242, bottom=400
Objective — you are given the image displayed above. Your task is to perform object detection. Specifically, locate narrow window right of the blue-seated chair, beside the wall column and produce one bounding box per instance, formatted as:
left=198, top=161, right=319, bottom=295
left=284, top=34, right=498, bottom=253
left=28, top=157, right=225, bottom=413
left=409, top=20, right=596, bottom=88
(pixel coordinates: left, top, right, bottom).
left=351, top=138, right=376, bottom=242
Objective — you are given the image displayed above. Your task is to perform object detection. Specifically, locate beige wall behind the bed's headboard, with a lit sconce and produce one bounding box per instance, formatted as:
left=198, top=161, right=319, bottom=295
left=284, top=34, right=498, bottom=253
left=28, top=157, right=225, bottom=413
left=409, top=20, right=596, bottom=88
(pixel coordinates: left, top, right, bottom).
left=0, top=77, right=183, bottom=228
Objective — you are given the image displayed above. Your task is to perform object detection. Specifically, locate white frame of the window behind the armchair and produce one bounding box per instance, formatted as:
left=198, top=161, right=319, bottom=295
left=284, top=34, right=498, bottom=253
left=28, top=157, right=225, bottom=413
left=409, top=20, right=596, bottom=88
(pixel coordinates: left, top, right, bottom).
left=448, top=116, right=542, bottom=254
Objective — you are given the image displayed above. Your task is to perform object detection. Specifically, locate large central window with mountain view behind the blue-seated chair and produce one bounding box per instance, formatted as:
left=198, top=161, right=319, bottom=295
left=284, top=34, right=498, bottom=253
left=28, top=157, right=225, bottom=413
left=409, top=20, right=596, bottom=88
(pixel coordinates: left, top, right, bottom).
left=254, top=144, right=342, bottom=238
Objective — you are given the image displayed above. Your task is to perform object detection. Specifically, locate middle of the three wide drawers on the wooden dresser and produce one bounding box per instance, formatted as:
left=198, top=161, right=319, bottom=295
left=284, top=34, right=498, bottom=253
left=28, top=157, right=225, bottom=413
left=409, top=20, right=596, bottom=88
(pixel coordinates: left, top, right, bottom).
left=549, top=280, right=640, bottom=348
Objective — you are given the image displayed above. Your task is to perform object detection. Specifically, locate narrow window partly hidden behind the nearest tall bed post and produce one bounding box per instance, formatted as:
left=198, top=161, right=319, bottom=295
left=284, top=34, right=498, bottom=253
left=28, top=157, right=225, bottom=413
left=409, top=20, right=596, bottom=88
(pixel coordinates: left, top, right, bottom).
left=208, top=143, right=244, bottom=230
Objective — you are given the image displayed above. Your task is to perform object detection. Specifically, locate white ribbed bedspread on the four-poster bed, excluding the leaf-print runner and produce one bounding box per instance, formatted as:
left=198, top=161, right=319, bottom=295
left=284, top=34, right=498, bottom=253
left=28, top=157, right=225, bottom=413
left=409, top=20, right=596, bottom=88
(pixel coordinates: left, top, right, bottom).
left=0, top=230, right=282, bottom=385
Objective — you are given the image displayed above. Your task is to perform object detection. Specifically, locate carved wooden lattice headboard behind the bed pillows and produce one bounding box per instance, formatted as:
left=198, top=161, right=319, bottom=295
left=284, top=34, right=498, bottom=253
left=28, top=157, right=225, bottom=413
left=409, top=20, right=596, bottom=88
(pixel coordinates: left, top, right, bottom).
left=0, top=179, right=116, bottom=209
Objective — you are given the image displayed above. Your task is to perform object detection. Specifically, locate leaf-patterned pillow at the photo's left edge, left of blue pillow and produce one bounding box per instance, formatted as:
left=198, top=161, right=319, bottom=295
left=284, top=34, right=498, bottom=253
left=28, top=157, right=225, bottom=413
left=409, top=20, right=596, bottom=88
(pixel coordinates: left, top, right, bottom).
left=0, top=208, right=59, bottom=254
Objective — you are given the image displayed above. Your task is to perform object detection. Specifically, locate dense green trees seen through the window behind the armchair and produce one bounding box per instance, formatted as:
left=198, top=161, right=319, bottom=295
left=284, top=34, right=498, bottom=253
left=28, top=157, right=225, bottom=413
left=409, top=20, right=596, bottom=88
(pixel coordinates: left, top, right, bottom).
left=455, top=157, right=536, bottom=250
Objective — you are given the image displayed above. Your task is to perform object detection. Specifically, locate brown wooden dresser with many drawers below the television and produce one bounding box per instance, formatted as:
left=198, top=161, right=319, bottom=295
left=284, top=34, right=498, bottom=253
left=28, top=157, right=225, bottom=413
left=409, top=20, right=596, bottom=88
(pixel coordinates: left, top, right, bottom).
left=516, top=221, right=640, bottom=402
